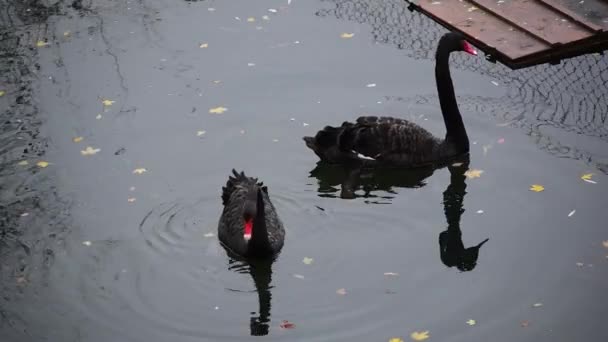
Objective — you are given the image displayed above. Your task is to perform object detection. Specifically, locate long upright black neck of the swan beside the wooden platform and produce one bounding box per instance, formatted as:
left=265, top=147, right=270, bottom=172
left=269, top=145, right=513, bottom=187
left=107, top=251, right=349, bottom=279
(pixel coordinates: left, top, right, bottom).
left=435, top=40, right=469, bottom=153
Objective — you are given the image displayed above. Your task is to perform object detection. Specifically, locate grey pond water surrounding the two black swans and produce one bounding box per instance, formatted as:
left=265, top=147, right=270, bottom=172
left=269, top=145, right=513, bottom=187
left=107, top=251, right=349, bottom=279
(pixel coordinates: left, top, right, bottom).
left=0, top=0, right=608, bottom=342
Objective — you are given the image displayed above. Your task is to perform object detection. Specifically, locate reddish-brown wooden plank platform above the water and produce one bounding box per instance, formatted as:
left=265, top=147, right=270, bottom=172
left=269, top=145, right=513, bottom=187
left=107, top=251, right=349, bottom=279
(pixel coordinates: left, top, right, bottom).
left=405, top=0, right=608, bottom=69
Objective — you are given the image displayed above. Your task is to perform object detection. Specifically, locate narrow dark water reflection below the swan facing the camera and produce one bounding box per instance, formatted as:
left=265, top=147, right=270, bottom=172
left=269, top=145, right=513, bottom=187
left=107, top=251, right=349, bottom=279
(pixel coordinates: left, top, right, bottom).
left=226, top=250, right=274, bottom=336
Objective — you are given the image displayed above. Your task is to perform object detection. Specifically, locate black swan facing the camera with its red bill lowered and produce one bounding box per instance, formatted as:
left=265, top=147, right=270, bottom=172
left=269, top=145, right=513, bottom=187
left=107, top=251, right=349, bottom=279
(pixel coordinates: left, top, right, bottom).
left=218, top=170, right=285, bottom=257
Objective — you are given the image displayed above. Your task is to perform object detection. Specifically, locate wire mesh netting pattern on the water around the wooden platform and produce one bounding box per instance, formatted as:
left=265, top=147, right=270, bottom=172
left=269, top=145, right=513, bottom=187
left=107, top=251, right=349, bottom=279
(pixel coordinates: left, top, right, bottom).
left=317, top=0, right=608, bottom=173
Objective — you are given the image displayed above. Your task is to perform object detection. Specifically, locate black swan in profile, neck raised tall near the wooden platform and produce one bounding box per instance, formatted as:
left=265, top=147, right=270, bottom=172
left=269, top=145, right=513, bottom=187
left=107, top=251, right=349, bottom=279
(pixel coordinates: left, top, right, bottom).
left=304, top=32, right=477, bottom=167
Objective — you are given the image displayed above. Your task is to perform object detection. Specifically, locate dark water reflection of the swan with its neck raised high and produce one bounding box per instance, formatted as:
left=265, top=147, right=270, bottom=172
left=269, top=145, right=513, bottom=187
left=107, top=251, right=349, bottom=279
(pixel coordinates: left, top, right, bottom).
left=310, top=156, right=489, bottom=272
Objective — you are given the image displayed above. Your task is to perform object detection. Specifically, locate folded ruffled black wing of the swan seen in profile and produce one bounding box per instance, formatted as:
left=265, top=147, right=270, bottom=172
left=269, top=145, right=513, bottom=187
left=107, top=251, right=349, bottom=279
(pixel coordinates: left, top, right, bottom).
left=340, top=116, right=441, bottom=165
